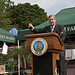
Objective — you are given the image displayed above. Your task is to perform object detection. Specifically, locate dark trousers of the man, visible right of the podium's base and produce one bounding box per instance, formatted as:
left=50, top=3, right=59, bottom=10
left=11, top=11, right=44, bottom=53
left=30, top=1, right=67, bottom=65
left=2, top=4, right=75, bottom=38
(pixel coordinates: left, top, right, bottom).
left=57, top=50, right=67, bottom=75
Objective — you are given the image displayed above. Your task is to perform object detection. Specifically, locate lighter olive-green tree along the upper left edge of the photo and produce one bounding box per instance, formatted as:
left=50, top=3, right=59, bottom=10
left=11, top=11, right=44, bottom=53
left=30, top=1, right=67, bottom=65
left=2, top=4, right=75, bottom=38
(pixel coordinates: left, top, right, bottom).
left=0, top=0, right=11, bottom=30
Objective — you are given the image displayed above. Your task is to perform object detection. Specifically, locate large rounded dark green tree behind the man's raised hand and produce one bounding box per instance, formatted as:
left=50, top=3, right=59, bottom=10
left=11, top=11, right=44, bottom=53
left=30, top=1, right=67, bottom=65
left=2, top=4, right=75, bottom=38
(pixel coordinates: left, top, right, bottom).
left=8, top=3, right=47, bottom=29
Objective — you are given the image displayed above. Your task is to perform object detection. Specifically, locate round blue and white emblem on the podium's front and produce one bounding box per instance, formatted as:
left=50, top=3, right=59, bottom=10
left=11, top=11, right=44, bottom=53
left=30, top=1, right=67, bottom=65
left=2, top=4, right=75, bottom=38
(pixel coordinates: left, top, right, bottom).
left=31, top=38, right=48, bottom=56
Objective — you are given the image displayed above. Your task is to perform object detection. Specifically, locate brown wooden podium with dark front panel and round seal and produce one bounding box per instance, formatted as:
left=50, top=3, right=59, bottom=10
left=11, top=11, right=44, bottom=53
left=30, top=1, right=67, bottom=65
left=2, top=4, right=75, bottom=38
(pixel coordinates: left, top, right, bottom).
left=25, top=32, right=64, bottom=75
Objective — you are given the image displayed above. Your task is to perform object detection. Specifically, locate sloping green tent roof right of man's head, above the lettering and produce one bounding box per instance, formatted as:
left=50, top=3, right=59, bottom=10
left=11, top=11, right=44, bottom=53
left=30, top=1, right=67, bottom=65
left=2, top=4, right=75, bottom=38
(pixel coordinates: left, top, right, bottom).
left=56, top=7, right=75, bottom=25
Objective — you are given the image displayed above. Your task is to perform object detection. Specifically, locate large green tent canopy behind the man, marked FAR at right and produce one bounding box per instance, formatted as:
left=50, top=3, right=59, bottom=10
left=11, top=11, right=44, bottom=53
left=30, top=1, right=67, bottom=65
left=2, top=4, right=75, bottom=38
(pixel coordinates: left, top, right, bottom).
left=18, top=7, right=75, bottom=40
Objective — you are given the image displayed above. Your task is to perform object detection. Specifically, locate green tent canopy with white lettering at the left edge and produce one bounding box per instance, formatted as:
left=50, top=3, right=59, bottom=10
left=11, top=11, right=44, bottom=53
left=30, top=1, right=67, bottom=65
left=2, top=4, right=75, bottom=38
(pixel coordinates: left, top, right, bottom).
left=0, top=29, right=16, bottom=43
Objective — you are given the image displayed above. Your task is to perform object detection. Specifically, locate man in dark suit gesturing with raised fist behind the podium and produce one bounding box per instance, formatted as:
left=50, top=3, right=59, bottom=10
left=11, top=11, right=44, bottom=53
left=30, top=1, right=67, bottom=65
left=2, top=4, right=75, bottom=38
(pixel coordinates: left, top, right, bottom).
left=28, top=15, right=67, bottom=75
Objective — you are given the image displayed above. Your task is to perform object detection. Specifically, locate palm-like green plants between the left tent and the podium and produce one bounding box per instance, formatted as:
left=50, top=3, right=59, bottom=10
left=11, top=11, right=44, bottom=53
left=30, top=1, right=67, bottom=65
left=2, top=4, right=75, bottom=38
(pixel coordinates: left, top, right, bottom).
left=0, top=43, right=32, bottom=69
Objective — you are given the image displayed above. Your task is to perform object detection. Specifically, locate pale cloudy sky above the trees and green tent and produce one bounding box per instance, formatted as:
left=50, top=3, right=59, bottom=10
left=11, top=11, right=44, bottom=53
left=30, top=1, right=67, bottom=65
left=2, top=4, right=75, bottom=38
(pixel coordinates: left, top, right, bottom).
left=11, top=0, right=75, bottom=16
